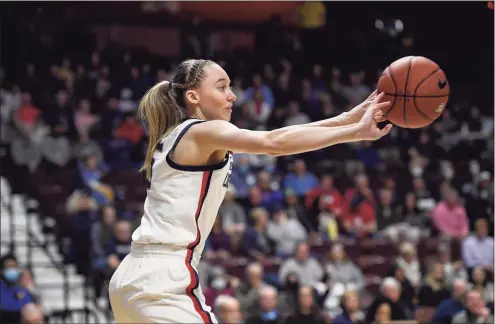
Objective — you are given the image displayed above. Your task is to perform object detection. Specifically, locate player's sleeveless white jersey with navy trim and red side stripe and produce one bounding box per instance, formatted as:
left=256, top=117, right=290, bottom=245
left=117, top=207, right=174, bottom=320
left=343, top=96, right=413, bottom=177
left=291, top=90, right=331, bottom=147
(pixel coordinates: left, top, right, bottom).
left=132, top=119, right=233, bottom=253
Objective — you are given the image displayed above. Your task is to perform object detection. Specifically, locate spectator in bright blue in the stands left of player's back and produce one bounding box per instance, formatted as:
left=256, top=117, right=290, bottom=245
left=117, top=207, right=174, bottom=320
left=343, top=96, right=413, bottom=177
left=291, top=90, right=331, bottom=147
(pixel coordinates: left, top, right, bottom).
left=79, top=156, right=115, bottom=205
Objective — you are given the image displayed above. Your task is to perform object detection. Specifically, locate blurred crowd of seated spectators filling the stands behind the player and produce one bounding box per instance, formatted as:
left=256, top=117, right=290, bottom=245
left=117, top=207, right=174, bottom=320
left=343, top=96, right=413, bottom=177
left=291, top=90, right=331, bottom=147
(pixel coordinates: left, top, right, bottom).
left=1, top=5, right=494, bottom=324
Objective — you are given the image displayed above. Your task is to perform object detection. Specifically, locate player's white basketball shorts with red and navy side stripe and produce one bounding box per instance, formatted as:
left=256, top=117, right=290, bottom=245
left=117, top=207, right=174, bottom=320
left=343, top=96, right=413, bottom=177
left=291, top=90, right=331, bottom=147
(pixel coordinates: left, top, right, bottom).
left=108, top=243, right=218, bottom=323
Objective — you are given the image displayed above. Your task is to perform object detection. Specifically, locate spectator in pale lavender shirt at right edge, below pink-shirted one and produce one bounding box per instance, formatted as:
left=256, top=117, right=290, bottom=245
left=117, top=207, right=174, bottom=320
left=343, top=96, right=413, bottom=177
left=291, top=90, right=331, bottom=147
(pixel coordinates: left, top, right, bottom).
left=462, top=218, right=493, bottom=274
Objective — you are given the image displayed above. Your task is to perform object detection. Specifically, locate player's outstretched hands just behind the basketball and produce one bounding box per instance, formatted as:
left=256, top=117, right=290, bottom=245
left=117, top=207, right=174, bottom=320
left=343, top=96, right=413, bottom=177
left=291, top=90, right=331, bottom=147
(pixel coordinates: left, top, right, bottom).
left=358, top=93, right=392, bottom=141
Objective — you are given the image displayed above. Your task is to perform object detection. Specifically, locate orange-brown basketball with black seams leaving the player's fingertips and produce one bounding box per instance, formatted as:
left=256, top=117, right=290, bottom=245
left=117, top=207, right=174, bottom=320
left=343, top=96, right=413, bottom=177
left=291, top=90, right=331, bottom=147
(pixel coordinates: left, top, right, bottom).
left=377, top=56, right=450, bottom=128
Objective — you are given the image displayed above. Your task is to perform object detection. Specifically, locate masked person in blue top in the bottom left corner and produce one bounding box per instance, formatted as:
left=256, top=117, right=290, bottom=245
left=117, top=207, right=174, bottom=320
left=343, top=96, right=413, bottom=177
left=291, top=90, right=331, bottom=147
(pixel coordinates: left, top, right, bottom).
left=0, top=254, right=34, bottom=324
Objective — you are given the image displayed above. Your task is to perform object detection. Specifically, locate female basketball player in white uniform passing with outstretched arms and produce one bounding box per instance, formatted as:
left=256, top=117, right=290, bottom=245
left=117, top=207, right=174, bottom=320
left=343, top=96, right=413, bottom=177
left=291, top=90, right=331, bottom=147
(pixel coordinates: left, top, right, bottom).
left=109, top=60, right=392, bottom=323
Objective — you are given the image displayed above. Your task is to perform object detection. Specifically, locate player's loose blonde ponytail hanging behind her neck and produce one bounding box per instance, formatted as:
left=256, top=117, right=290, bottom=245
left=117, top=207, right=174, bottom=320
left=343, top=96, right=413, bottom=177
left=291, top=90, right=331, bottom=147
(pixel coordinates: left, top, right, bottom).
left=139, top=81, right=182, bottom=180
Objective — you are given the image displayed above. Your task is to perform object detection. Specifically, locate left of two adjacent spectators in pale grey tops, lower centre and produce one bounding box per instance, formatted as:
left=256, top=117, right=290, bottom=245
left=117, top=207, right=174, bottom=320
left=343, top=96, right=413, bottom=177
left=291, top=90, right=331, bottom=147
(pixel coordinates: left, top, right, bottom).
left=278, top=242, right=324, bottom=286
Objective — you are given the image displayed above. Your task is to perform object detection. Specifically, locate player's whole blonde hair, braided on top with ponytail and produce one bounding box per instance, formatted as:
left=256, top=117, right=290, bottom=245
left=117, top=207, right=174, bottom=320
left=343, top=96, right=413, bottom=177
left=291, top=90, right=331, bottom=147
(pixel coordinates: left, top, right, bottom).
left=139, top=60, right=214, bottom=180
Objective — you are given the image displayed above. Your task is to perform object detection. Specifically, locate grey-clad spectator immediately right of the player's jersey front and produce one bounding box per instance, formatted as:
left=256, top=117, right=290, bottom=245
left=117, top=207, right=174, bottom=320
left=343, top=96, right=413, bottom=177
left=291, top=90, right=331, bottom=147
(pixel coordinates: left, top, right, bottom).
left=218, top=184, right=247, bottom=240
